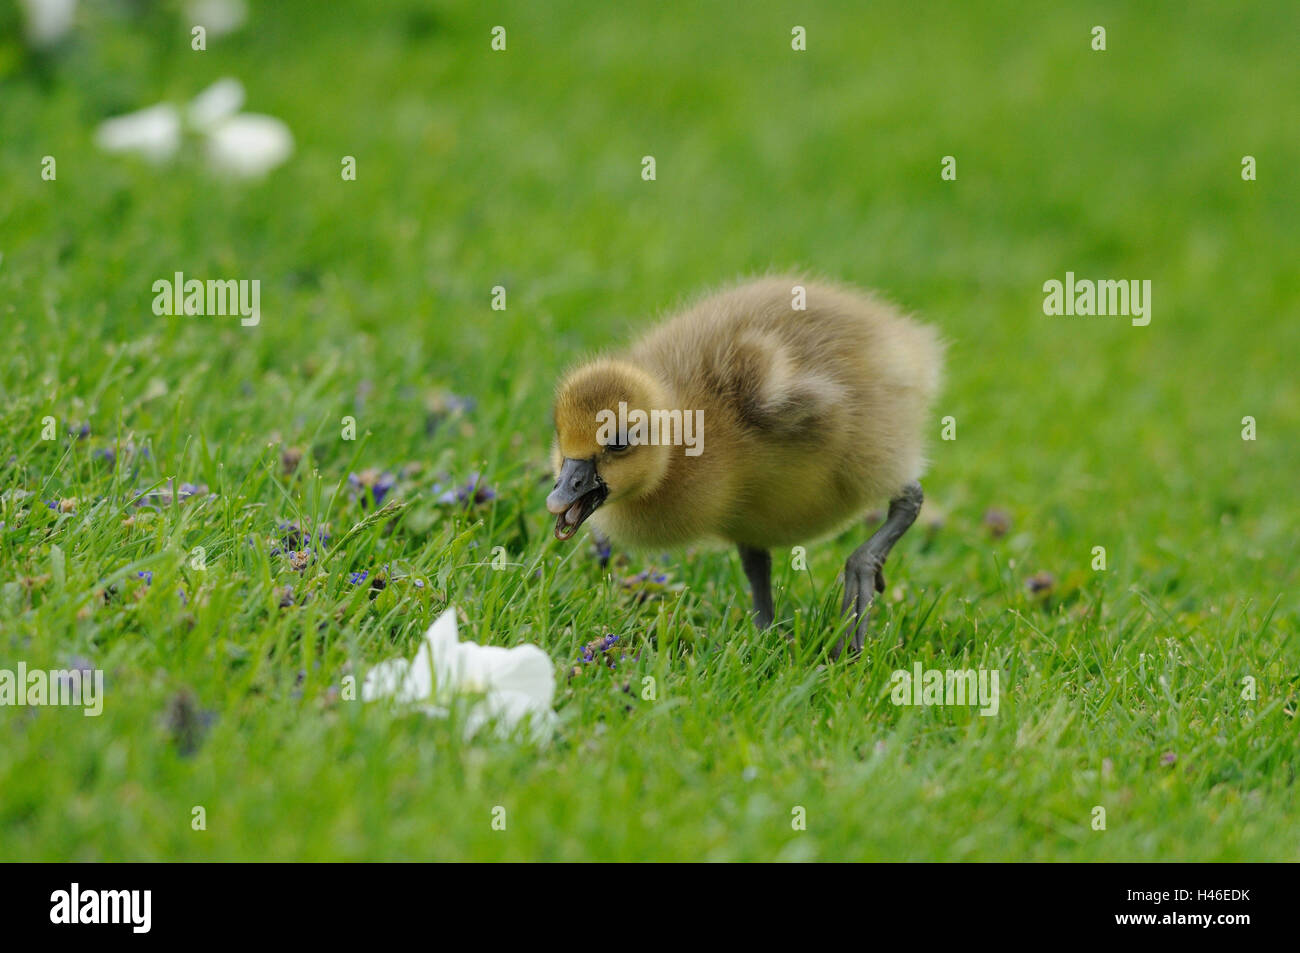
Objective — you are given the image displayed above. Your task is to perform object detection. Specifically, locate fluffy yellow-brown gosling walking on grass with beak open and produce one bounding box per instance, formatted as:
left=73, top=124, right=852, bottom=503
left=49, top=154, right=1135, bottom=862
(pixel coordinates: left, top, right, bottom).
left=546, top=271, right=944, bottom=658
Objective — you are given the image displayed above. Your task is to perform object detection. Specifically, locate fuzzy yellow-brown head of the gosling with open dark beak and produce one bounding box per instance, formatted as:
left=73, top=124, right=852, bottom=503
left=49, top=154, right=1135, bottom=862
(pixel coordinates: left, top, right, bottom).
left=546, top=360, right=671, bottom=540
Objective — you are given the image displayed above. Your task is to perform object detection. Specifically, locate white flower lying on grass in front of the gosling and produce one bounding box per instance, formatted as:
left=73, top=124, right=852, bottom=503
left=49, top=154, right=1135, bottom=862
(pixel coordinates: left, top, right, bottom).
left=361, top=608, right=555, bottom=741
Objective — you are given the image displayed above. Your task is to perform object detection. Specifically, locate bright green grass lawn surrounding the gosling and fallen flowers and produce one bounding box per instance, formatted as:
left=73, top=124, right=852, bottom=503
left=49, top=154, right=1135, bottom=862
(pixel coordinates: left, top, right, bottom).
left=0, top=1, right=1300, bottom=861
